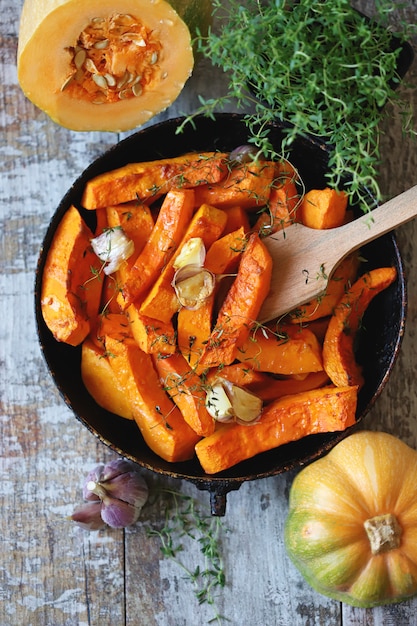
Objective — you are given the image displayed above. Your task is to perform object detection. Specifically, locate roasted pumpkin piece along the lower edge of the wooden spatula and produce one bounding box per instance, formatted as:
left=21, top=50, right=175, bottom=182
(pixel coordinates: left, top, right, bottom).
left=289, top=252, right=359, bottom=324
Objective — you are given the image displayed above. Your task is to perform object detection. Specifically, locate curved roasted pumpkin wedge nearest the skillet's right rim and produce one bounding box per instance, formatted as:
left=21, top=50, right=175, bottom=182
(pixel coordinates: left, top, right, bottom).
left=323, top=267, right=397, bottom=387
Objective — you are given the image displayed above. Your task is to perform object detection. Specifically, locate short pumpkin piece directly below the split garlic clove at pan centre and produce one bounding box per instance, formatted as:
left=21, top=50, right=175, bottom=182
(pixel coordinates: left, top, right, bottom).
left=177, top=292, right=215, bottom=369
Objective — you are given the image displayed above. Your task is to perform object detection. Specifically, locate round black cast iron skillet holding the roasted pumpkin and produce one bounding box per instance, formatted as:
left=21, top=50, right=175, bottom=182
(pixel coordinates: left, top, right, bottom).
left=35, top=113, right=406, bottom=515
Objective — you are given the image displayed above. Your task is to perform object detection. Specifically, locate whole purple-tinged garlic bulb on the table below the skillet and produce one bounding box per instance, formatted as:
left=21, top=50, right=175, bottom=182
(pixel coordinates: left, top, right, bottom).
left=72, top=459, right=148, bottom=530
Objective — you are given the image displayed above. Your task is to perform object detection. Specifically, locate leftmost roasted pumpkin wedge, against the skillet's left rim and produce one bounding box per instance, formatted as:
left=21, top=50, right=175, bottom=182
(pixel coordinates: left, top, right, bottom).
left=41, top=206, right=103, bottom=346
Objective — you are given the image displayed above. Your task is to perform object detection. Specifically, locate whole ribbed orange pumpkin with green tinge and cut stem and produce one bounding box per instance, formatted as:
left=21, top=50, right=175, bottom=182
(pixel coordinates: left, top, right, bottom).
left=285, top=431, right=417, bottom=608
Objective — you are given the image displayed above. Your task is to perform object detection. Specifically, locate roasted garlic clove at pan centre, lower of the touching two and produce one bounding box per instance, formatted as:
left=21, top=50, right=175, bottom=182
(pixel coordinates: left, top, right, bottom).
left=172, top=265, right=216, bottom=310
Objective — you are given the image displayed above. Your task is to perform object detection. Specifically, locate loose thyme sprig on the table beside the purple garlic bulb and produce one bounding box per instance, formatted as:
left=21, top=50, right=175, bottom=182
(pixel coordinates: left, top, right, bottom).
left=142, top=487, right=229, bottom=625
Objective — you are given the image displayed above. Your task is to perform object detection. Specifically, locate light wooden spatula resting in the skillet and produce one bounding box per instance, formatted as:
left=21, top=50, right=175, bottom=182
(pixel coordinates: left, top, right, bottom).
left=258, top=185, right=417, bottom=323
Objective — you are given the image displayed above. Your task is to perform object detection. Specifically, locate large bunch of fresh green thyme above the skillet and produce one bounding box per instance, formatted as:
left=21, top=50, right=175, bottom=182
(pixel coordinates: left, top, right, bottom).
left=188, top=0, right=416, bottom=210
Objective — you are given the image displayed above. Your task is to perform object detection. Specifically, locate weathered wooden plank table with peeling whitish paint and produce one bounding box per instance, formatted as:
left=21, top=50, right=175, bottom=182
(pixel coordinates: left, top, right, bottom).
left=0, top=0, right=417, bottom=626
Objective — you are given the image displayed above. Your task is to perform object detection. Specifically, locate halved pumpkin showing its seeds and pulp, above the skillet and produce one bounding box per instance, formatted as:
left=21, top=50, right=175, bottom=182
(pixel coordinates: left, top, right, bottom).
left=17, top=0, right=211, bottom=132
